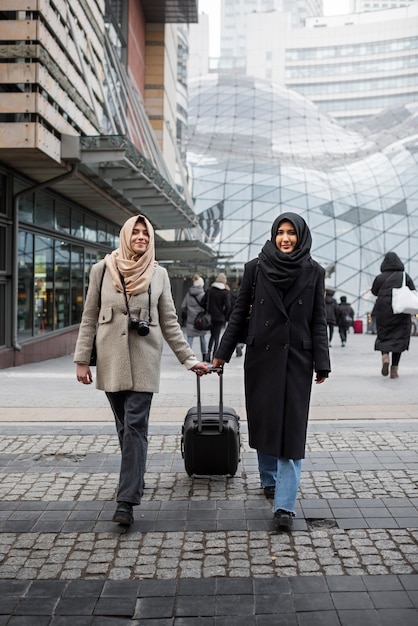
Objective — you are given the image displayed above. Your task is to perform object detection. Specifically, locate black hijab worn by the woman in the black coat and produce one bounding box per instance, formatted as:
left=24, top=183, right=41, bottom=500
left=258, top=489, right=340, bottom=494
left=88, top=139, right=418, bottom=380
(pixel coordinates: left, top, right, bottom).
left=258, top=213, right=312, bottom=291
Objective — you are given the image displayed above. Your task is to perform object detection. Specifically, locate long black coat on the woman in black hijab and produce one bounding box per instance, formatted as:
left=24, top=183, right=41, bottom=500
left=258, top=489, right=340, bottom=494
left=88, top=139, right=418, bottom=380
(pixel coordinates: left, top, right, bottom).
left=215, top=259, right=331, bottom=459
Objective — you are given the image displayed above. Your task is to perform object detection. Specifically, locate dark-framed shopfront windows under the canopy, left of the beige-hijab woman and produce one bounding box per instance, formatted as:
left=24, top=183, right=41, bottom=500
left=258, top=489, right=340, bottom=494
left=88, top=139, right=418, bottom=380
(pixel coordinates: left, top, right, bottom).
left=14, top=178, right=119, bottom=345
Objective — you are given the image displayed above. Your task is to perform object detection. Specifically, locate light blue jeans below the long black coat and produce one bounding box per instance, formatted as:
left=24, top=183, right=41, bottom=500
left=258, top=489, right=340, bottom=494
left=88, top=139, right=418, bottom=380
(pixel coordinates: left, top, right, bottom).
left=257, top=450, right=302, bottom=513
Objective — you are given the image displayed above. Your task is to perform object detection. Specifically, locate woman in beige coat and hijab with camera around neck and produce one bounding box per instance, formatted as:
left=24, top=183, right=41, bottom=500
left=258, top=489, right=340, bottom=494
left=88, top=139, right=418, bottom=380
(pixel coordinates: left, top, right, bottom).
left=74, top=215, right=209, bottom=526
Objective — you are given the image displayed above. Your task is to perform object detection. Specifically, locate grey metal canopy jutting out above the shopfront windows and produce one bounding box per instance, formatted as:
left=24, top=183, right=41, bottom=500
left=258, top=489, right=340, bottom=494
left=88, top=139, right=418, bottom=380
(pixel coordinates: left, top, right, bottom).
left=0, top=130, right=215, bottom=262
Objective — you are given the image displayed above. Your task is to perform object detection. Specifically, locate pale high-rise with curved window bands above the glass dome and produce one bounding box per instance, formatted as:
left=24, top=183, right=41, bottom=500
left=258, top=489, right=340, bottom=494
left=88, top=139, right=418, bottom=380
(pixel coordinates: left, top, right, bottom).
left=246, top=4, right=418, bottom=123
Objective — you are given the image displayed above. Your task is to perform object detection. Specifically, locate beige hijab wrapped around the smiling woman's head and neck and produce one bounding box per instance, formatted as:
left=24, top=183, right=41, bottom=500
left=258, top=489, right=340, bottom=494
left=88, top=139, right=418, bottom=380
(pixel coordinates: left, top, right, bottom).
left=105, top=215, right=157, bottom=296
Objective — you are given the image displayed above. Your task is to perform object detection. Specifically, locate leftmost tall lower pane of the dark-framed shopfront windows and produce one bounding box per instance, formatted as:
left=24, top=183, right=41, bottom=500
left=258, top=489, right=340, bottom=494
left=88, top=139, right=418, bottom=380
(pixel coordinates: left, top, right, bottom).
left=17, top=232, right=34, bottom=339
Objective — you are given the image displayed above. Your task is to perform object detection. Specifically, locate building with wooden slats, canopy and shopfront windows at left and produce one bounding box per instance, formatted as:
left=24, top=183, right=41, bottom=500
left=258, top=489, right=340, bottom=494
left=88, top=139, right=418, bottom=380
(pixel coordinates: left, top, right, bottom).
left=0, top=0, right=212, bottom=367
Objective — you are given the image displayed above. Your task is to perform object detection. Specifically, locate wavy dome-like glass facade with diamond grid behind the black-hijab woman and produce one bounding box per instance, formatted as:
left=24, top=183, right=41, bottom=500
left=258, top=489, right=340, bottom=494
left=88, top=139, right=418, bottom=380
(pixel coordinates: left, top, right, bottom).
left=188, top=75, right=418, bottom=315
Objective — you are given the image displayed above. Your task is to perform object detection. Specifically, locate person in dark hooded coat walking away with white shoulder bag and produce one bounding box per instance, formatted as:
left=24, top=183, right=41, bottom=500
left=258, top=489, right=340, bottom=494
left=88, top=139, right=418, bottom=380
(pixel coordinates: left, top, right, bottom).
left=372, top=252, right=415, bottom=378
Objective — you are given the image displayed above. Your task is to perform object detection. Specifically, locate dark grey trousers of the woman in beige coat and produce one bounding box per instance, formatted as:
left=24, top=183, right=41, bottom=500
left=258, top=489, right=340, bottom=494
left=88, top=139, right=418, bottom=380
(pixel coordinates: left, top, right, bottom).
left=106, top=391, right=153, bottom=505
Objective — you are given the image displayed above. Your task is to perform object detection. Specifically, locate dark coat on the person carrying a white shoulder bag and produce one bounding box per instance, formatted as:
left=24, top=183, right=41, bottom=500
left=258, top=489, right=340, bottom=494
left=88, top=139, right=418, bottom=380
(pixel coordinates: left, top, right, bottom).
left=372, top=265, right=415, bottom=352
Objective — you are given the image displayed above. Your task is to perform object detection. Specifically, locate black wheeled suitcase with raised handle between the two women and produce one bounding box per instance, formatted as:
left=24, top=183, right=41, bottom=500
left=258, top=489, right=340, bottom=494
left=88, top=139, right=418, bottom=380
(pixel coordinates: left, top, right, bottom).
left=181, top=370, right=240, bottom=476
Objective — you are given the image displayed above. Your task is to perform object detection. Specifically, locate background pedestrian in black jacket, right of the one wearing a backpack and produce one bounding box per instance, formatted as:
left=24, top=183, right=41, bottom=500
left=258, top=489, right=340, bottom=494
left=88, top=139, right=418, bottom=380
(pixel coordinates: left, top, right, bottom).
left=202, top=272, right=231, bottom=360
